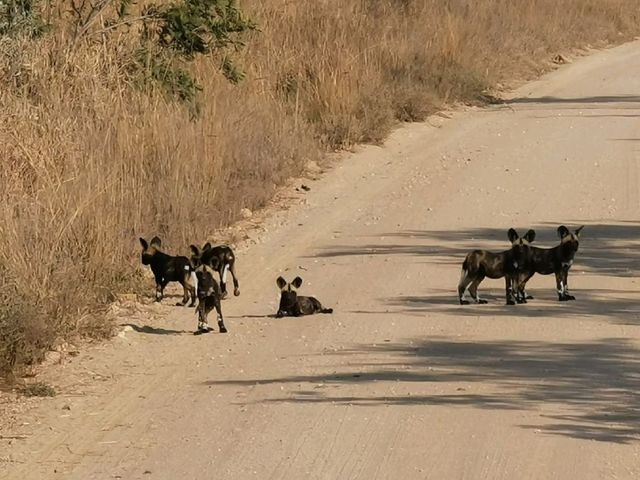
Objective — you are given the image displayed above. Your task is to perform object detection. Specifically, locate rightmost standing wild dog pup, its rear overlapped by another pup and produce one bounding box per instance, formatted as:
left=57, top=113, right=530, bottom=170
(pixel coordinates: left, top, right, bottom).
left=517, top=225, right=584, bottom=302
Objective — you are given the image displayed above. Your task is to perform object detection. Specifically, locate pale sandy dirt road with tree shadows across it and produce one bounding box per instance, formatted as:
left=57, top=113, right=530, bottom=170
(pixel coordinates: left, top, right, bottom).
left=0, top=42, right=640, bottom=480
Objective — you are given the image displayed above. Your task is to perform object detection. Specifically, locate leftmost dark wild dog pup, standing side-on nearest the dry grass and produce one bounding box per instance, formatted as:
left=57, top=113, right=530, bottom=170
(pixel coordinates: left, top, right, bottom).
left=140, top=237, right=198, bottom=307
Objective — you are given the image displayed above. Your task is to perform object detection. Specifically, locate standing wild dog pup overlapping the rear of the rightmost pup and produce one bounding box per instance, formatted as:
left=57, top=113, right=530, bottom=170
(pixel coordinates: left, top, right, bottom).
left=458, top=228, right=536, bottom=305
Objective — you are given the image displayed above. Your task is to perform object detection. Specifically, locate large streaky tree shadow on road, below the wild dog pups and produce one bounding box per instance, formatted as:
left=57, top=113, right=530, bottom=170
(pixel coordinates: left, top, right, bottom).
left=207, top=338, right=640, bottom=443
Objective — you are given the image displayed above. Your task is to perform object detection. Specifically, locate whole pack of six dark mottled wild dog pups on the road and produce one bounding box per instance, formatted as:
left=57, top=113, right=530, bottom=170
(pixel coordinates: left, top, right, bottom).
left=140, top=225, right=584, bottom=334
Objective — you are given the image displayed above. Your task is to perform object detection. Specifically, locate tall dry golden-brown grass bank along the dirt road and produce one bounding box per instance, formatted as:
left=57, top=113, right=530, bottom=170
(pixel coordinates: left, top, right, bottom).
left=0, top=0, right=640, bottom=376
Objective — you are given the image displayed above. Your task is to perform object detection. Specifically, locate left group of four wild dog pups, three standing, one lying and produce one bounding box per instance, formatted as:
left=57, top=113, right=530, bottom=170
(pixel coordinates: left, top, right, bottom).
left=140, top=237, right=333, bottom=335
